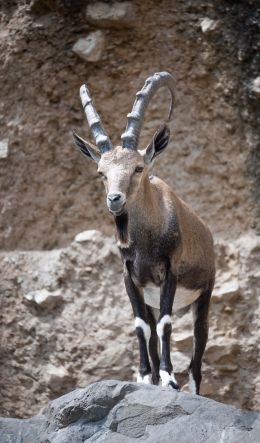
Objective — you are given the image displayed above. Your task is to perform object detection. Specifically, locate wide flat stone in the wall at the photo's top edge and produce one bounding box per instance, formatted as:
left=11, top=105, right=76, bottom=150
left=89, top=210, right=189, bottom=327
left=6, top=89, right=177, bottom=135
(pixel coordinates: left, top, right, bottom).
left=86, top=2, right=135, bottom=28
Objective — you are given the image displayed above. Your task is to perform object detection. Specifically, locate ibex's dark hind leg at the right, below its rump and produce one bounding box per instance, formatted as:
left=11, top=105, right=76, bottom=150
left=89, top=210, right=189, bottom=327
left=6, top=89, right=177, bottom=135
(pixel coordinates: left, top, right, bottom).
left=189, top=290, right=212, bottom=395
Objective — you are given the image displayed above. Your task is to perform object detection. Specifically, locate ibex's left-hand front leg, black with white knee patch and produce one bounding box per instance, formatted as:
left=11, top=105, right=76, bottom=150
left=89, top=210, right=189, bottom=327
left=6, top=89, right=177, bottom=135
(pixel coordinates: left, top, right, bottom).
left=124, top=266, right=152, bottom=384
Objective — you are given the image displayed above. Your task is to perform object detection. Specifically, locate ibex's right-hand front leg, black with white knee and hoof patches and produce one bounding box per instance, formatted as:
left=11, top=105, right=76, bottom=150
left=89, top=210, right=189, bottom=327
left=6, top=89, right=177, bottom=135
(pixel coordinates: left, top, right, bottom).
left=156, top=269, right=180, bottom=390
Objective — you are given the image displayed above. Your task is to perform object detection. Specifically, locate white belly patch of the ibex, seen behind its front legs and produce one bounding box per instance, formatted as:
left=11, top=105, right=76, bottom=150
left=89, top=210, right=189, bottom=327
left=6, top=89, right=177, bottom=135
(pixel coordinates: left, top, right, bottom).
left=144, top=286, right=201, bottom=312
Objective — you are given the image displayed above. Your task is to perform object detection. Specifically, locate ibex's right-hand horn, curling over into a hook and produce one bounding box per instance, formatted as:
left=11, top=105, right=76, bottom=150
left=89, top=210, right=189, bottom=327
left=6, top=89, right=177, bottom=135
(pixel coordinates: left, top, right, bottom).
left=121, top=72, right=175, bottom=150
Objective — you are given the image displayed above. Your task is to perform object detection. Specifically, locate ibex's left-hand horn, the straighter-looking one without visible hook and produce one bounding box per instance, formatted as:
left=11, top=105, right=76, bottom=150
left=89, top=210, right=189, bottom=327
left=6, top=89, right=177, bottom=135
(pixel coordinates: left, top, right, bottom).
left=79, top=85, right=113, bottom=154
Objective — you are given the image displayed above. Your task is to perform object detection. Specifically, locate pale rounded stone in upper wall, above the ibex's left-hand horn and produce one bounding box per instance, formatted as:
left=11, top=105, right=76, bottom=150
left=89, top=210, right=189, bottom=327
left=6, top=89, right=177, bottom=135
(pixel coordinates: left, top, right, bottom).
left=72, top=31, right=105, bottom=62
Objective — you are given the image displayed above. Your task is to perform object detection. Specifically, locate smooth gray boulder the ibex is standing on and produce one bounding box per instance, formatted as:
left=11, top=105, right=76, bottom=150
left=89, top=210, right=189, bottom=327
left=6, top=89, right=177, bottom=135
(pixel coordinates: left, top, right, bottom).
left=0, top=380, right=260, bottom=443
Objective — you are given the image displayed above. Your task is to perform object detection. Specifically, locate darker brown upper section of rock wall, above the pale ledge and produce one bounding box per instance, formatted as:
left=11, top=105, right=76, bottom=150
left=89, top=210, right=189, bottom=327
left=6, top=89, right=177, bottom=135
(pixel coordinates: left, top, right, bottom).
left=0, top=0, right=259, bottom=249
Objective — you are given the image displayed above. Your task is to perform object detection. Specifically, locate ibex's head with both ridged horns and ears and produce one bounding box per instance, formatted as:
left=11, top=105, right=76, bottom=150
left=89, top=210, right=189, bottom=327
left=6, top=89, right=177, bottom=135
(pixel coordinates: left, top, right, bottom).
left=73, top=72, right=174, bottom=216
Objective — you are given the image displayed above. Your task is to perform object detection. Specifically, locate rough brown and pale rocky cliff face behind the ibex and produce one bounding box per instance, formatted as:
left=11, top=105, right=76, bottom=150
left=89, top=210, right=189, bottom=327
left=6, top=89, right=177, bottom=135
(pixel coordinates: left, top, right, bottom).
left=0, top=0, right=260, bottom=417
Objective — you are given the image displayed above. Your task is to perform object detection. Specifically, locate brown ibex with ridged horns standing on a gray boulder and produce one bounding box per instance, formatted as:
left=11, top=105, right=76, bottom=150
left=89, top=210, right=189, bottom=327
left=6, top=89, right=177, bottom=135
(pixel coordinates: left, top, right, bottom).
left=74, top=72, right=215, bottom=394
